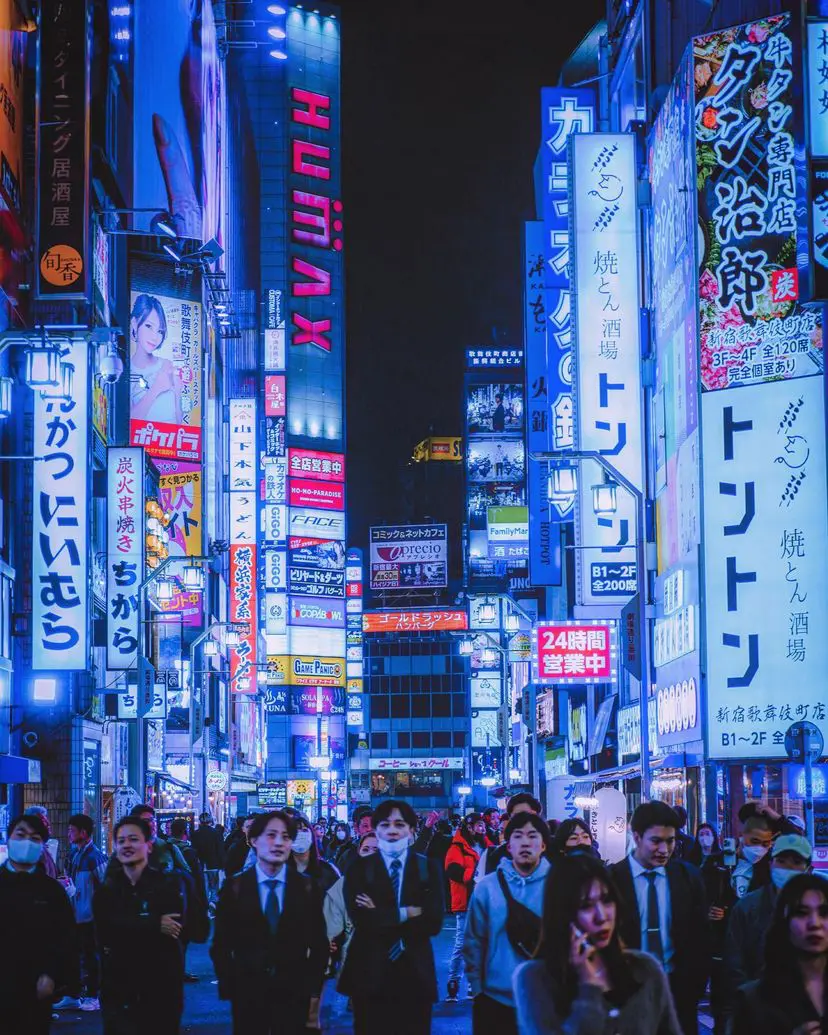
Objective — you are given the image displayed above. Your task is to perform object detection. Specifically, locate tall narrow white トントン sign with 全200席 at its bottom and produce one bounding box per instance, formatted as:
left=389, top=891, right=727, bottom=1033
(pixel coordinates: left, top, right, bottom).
left=569, top=134, right=643, bottom=604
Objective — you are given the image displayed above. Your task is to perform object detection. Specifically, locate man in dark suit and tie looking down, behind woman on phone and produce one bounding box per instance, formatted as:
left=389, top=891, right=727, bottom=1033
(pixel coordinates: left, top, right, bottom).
left=610, top=801, right=710, bottom=1035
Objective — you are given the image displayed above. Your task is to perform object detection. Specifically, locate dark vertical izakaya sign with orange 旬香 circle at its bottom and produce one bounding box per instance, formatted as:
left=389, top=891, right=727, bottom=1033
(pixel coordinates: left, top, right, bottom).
left=35, top=0, right=90, bottom=299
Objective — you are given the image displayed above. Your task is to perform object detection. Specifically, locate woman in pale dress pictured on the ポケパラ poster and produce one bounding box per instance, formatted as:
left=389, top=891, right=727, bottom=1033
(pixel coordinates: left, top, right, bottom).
left=129, top=294, right=183, bottom=424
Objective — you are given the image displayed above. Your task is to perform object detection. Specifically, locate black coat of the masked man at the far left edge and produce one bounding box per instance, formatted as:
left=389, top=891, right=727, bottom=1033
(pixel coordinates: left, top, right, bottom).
left=0, top=866, right=80, bottom=1001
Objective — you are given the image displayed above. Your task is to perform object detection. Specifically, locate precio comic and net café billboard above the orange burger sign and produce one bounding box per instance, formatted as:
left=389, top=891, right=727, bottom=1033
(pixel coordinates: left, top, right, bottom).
left=368, top=525, right=448, bottom=589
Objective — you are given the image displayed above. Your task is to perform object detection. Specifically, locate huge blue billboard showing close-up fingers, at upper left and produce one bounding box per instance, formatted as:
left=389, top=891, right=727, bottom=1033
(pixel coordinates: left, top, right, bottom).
left=132, top=0, right=219, bottom=243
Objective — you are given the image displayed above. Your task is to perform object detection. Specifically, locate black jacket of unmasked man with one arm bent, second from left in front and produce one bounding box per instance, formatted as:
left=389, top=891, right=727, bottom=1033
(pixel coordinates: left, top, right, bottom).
left=92, top=866, right=187, bottom=1009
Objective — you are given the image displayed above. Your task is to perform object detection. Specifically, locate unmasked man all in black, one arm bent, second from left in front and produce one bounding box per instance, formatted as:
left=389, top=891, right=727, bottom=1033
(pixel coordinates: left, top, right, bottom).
left=92, top=816, right=188, bottom=1035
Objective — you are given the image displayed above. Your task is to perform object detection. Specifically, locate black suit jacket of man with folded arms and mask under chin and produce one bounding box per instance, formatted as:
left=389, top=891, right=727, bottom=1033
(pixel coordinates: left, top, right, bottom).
left=339, top=851, right=444, bottom=1002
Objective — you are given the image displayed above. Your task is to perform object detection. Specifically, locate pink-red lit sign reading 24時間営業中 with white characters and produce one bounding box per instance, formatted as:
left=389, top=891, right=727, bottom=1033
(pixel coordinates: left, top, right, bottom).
left=532, top=621, right=618, bottom=685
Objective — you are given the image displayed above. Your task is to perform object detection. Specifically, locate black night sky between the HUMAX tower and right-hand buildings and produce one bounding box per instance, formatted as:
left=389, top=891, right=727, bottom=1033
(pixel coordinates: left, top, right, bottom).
left=341, top=0, right=604, bottom=544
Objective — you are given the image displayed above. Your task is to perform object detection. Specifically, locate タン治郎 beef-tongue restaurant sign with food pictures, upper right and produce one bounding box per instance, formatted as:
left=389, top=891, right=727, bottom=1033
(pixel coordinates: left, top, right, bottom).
left=693, top=13, right=824, bottom=391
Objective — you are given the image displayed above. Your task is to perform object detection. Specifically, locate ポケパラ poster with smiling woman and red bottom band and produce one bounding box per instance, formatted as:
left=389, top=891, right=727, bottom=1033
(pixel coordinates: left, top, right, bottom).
left=129, top=263, right=202, bottom=462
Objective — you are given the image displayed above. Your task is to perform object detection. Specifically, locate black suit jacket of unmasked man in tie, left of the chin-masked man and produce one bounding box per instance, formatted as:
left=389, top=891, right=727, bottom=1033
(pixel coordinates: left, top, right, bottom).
left=210, top=867, right=328, bottom=1011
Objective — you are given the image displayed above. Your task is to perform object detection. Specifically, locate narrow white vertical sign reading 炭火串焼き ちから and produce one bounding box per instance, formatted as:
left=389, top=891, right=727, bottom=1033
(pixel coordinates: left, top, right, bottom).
left=107, top=446, right=144, bottom=672
